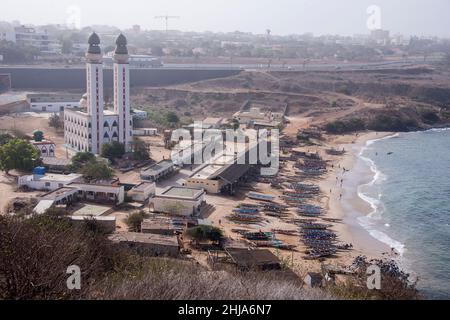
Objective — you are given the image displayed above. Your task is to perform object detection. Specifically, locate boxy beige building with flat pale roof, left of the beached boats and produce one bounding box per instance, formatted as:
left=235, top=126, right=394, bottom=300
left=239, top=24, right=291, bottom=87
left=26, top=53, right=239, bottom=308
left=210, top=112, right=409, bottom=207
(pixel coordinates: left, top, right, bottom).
left=150, top=187, right=205, bottom=216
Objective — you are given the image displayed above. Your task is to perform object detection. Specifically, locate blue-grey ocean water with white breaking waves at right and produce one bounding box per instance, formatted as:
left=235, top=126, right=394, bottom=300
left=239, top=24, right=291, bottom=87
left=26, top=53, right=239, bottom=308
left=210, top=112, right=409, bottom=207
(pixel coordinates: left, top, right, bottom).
left=358, top=129, right=450, bottom=299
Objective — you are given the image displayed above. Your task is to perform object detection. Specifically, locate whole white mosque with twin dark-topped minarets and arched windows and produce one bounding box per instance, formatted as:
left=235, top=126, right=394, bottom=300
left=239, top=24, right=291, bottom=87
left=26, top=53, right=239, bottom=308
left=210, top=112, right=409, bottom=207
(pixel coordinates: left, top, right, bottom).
left=64, top=32, right=133, bottom=154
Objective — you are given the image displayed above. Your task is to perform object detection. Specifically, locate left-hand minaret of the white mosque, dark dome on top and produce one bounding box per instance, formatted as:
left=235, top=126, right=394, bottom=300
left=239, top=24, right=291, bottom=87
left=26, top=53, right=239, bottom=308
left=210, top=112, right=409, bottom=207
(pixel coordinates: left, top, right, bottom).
left=86, top=32, right=104, bottom=154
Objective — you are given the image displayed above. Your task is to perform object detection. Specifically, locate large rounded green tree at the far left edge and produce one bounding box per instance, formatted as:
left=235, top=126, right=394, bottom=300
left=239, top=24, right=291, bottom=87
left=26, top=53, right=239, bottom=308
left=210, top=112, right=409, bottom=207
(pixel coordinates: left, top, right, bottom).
left=0, top=139, right=40, bottom=173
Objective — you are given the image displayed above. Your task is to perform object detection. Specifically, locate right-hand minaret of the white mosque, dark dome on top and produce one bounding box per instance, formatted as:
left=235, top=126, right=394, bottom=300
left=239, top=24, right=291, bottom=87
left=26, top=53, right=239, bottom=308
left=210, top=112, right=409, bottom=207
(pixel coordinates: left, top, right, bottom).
left=114, top=34, right=133, bottom=151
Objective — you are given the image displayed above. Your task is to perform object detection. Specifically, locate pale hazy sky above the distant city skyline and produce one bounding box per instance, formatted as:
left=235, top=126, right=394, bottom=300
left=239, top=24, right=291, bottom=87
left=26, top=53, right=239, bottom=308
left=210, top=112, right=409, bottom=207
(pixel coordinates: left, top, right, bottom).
left=0, top=0, right=450, bottom=37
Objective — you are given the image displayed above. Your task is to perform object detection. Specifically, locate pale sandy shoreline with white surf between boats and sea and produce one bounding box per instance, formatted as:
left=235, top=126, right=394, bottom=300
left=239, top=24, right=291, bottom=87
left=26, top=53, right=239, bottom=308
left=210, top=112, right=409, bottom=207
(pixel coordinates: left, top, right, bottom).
left=319, top=132, right=396, bottom=263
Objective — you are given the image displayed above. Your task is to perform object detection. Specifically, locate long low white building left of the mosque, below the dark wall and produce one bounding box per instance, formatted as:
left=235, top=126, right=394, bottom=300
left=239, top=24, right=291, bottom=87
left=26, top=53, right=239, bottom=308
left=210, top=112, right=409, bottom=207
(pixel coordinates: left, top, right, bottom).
left=27, top=93, right=81, bottom=112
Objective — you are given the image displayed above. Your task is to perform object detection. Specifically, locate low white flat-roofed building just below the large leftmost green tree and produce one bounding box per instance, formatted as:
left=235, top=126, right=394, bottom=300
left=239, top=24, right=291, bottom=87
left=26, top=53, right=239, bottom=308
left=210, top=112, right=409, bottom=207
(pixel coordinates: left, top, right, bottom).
left=18, top=173, right=83, bottom=191
